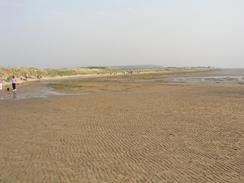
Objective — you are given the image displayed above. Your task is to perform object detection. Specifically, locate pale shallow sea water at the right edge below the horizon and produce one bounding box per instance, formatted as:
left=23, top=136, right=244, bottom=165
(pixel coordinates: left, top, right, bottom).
left=166, top=69, right=244, bottom=84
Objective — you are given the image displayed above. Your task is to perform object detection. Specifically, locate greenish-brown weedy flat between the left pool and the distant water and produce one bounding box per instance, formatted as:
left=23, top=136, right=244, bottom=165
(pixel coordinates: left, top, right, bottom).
left=48, top=68, right=213, bottom=92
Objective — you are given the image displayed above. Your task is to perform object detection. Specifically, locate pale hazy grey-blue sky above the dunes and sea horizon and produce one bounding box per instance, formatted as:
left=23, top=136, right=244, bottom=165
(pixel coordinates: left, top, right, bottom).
left=0, top=0, right=244, bottom=67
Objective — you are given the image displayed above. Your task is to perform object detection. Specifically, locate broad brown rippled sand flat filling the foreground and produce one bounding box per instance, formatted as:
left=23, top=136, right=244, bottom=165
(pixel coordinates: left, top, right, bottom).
left=0, top=74, right=244, bottom=183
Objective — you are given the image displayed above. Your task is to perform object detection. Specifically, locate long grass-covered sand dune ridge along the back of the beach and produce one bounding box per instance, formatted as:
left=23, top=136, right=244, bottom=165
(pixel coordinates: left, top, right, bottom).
left=0, top=66, right=209, bottom=82
